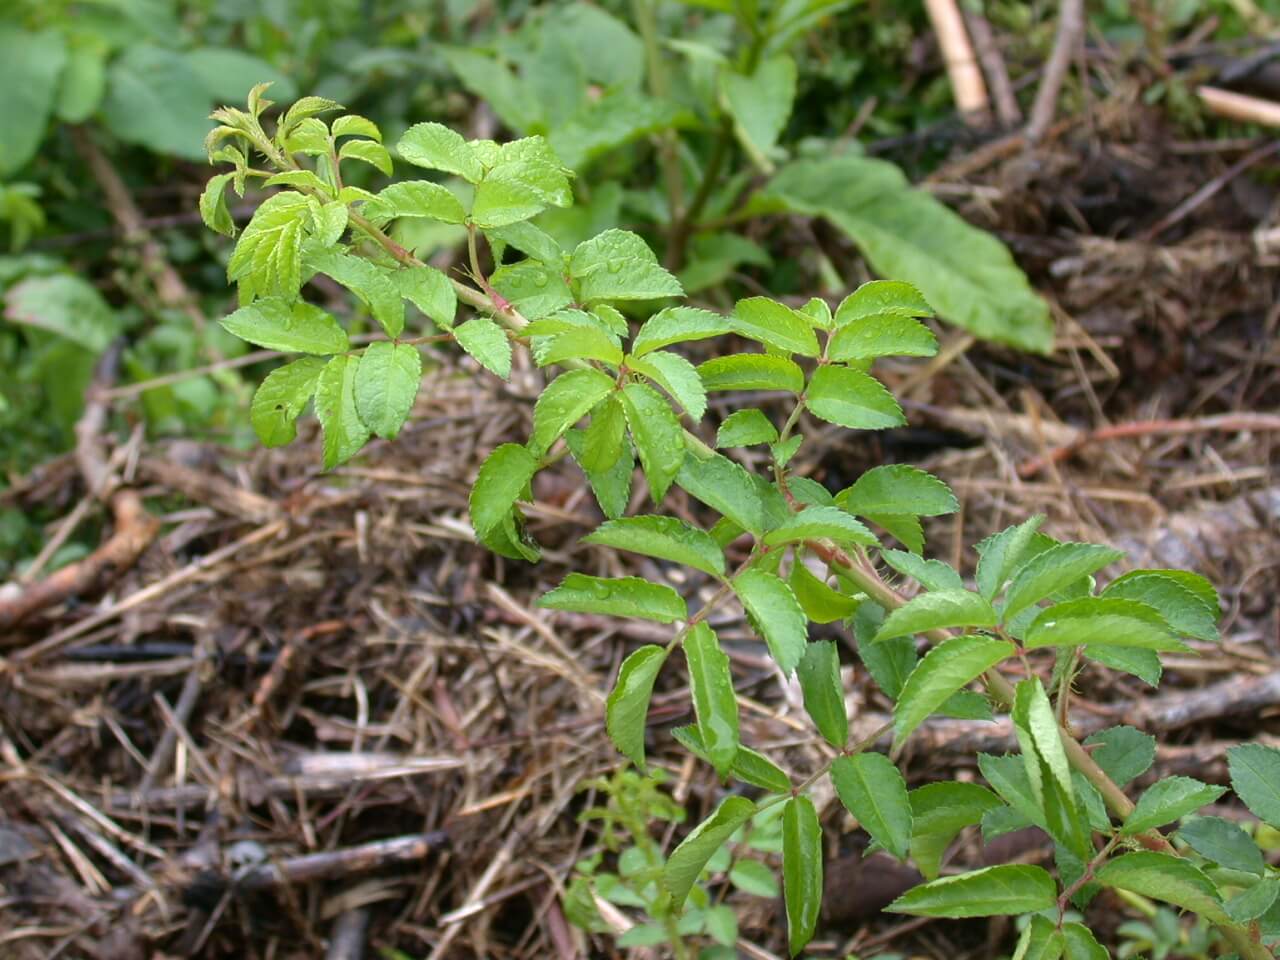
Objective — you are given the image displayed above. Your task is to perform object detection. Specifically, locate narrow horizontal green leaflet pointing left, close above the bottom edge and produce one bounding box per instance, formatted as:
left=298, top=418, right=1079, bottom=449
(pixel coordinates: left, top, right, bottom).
left=884, top=864, right=1057, bottom=918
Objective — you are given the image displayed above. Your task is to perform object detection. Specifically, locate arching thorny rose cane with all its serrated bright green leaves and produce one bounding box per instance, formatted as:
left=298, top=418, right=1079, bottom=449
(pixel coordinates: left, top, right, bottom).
left=200, top=87, right=1280, bottom=960
